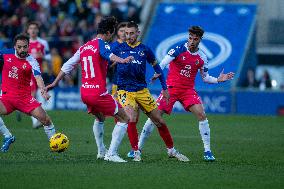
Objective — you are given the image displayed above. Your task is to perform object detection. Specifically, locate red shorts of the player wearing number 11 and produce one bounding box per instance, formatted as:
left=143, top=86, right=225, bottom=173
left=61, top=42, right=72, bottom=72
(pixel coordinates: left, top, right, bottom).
left=81, top=94, right=121, bottom=116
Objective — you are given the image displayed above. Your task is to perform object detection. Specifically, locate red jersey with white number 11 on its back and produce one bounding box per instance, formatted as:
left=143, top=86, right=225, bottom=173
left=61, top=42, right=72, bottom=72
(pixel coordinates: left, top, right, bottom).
left=61, top=38, right=112, bottom=95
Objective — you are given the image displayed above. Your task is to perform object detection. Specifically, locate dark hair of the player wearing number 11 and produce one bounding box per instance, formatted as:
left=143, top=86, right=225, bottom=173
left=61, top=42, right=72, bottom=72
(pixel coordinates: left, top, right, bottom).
left=97, top=16, right=117, bottom=34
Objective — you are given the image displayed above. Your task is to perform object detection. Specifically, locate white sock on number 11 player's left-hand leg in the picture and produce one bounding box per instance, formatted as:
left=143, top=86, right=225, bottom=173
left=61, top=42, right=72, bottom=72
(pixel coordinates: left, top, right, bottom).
left=93, top=120, right=106, bottom=152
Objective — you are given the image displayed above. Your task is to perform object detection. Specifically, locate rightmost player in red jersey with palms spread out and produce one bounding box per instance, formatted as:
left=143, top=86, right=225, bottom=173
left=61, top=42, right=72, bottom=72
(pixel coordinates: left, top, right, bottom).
left=138, top=26, right=234, bottom=161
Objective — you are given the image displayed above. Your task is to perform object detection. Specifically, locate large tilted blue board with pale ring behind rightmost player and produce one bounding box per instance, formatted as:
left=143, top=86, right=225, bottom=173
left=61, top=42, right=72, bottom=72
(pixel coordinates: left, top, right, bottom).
left=145, top=3, right=256, bottom=90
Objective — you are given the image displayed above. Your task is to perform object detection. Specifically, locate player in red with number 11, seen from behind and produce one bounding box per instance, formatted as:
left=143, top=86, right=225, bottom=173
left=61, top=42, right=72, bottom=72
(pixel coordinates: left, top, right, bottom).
left=46, top=17, right=133, bottom=162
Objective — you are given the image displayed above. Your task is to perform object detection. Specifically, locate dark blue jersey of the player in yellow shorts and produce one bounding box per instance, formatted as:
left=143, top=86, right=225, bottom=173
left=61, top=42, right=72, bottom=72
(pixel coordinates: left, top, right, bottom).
left=112, top=42, right=156, bottom=92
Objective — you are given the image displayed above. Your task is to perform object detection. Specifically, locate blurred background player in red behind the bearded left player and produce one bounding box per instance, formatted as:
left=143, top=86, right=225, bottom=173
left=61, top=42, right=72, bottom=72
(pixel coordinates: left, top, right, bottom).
left=27, top=21, right=51, bottom=128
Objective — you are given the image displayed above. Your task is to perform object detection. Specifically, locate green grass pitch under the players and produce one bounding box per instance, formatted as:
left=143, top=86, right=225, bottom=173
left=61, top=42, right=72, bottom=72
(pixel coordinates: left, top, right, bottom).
left=0, top=111, right=284, bottom=189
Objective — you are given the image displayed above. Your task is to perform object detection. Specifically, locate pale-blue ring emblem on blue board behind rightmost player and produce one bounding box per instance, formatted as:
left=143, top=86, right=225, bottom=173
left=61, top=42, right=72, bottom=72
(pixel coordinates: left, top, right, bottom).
left=156, top=32, right=232, bottom=68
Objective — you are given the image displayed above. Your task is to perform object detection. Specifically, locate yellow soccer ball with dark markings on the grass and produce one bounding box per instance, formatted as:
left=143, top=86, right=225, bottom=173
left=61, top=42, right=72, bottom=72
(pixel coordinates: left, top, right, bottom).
left=49, top=133, right=69, bottom=152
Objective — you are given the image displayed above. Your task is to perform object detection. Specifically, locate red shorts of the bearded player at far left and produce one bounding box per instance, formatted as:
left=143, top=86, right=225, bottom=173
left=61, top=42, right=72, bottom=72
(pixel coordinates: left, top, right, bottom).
left=0, top=95, right=41, bottom=115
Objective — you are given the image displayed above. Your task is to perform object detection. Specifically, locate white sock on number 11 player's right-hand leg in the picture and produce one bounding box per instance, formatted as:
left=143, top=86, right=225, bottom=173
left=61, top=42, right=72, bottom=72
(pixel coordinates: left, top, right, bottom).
left=108, top=122, right=127, bottom=155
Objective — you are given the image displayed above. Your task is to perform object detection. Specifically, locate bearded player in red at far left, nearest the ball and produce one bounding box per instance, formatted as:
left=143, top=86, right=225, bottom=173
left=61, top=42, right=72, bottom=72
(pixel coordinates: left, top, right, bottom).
left=0, top=34, right=55, bottom=152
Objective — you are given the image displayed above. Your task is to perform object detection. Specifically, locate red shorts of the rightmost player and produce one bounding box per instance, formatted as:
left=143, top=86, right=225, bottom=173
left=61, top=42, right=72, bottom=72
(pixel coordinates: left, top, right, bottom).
left=157, top=88, right=202, bottom=114
